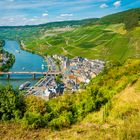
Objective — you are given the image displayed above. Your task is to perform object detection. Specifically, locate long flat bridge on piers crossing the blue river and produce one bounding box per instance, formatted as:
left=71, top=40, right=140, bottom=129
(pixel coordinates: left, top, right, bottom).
left=0, top=71, right=61, bottom=79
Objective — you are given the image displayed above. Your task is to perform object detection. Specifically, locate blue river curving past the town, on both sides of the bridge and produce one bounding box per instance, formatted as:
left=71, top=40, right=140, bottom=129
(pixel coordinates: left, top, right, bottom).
left=0, top=40, right=47, bottom=88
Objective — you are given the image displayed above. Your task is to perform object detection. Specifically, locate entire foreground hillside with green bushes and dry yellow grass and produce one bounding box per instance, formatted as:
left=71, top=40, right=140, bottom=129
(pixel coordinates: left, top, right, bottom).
left=0, top=59, right=140, bottom=140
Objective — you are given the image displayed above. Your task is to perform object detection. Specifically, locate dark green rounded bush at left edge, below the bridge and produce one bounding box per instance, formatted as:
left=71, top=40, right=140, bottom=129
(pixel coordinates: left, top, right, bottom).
left=0, top=86, right=25, bottom=120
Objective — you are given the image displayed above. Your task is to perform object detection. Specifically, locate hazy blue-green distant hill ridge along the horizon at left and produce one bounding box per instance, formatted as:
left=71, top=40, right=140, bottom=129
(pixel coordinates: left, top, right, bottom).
left=0, top=18, right=99, bottom=40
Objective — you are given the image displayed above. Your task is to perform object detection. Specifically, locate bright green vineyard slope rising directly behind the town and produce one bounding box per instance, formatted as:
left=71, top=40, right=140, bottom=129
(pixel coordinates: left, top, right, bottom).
left=24, top=24, right=140, bottom=61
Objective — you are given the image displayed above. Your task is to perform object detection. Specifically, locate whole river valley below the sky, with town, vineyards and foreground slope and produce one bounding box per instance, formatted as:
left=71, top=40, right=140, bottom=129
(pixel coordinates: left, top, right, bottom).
left=0, top=5, right=140, bottom=140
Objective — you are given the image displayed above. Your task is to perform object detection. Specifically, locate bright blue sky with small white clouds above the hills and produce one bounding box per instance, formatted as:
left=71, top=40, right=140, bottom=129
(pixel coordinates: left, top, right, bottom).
left=0, top=0, right=140, bottom=26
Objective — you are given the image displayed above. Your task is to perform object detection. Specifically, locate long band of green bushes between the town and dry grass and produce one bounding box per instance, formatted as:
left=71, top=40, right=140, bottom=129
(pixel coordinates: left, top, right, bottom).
left=0, top=59, right=140, bottom=129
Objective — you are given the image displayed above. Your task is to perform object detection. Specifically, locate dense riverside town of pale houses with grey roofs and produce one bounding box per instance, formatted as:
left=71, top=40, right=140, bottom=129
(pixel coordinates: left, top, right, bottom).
left=27, top=55, right=105, bottom=99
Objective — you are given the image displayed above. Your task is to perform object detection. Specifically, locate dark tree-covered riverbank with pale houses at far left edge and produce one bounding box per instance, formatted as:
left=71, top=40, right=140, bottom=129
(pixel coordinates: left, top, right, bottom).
left=0, top=40, right=15, bottom=72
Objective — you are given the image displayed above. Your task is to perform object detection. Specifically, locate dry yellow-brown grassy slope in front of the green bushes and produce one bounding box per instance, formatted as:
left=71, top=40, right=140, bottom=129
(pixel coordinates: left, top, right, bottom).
left=0, top=79, right=140, bottom=140
